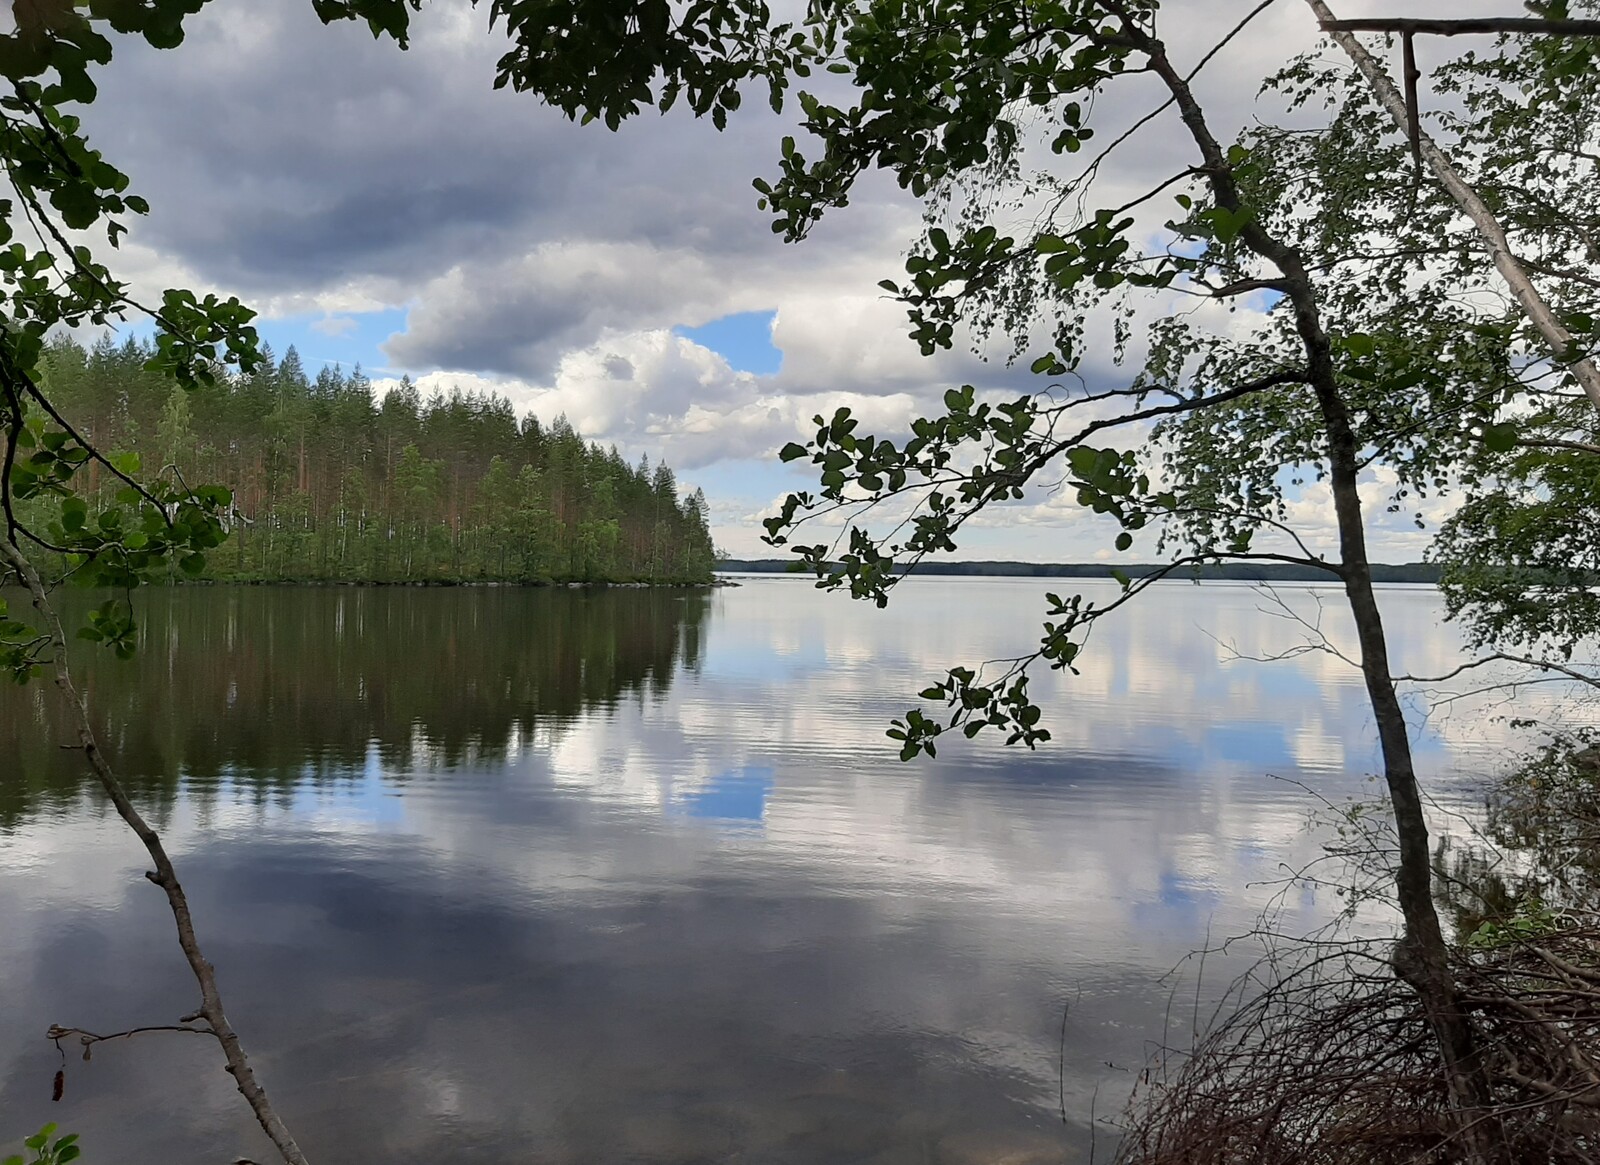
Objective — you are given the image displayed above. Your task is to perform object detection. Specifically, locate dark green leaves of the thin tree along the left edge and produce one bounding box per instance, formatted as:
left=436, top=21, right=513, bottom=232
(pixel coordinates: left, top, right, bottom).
left=0, top=0, right=268, bottom=665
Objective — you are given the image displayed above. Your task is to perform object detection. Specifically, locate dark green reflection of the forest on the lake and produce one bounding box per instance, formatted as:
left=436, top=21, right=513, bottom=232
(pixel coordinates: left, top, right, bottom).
left=0, top=587, right=709, bottom=824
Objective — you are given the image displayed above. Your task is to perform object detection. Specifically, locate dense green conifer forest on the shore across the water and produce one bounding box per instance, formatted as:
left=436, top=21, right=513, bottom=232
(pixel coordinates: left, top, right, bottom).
left=23, top=338, right=714, bottom=583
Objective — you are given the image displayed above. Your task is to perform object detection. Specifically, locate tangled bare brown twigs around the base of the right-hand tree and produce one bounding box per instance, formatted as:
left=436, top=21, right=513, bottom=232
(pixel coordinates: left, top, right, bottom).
left=1118, top=927, right=1600, bottom=1165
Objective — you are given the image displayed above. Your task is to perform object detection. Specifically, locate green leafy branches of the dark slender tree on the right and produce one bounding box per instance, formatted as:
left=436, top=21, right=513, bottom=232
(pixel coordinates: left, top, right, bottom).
left=742, top=0, right=1594, bottom=755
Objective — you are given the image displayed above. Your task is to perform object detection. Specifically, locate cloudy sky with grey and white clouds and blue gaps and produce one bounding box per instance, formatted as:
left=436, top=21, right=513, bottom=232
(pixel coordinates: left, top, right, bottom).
left=68, top=0, right=1509, bottom=562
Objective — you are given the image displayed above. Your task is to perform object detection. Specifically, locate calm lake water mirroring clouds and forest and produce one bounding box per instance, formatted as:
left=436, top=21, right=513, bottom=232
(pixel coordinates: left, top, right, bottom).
left=0, top=578, right=1546, bottom=1165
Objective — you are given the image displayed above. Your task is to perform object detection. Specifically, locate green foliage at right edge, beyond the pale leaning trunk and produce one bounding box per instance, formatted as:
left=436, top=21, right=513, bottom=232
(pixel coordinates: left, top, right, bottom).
left=1434, top=0, right=1600, bottom=658
